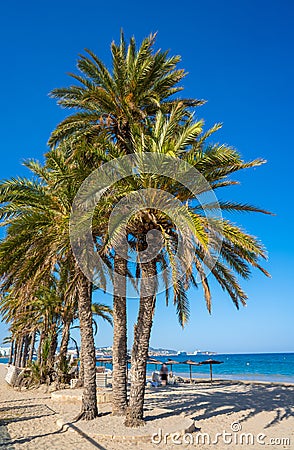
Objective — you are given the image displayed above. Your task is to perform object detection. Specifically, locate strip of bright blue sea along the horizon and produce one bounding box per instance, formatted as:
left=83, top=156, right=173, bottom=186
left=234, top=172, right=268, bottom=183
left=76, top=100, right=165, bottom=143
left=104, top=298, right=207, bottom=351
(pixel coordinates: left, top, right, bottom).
left=0, top=353, right=294, bottom=383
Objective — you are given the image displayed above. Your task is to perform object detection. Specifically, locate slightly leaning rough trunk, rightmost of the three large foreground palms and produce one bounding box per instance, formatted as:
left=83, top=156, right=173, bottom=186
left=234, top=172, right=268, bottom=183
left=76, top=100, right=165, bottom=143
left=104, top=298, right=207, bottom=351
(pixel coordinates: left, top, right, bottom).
left=125, top=261, right=156, bottom=427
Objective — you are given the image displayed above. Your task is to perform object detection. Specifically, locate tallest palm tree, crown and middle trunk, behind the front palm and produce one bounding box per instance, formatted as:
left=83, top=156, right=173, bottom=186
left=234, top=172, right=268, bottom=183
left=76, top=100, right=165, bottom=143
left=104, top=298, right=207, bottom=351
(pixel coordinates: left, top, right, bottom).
left=49, top=33, right=203, bottom=415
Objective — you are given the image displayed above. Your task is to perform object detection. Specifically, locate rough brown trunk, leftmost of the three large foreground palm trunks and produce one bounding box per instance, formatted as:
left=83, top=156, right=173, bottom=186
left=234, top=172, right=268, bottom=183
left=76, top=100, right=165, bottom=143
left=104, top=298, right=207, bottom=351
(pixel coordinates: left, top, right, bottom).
left=77, top=269, right=98, bottom=420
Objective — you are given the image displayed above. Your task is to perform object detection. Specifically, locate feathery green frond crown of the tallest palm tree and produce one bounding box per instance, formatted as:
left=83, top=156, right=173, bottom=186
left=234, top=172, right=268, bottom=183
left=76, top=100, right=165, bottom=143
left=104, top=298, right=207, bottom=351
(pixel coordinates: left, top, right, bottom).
left=49, top=32, right=203, bottom=154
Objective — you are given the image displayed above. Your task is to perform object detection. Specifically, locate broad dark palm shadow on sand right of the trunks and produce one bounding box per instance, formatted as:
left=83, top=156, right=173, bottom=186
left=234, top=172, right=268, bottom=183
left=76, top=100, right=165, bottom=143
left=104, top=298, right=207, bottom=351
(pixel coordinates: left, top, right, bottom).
left=145, top=383, right=294, bottom=428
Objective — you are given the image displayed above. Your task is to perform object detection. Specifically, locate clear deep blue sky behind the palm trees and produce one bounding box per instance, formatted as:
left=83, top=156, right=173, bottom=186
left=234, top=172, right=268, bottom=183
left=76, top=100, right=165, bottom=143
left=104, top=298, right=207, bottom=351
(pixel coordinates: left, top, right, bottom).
left=0, top=0, right=294, bottom=352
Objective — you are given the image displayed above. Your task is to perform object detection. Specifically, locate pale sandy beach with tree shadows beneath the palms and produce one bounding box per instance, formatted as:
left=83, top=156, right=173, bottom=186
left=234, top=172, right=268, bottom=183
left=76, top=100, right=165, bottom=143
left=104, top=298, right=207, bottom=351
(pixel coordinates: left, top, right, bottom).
left=0, top=364, right=294, bottom=450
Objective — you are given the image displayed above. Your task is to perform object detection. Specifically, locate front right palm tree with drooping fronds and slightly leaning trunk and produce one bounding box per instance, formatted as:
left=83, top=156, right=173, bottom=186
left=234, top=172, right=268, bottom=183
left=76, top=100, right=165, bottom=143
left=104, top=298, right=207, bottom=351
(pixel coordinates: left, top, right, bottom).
left=99, top=106, right=268, bottom=426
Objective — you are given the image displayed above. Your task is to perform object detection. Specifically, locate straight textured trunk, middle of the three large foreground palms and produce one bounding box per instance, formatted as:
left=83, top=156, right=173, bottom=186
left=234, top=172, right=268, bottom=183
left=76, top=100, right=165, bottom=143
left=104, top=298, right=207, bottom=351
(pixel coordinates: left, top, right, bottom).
left=112, top=255, right=127, bottom=416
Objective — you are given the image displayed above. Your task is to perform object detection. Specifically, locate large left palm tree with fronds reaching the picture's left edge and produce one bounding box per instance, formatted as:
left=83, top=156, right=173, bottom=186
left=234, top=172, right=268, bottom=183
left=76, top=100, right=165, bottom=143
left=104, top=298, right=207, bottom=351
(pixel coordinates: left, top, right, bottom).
left=0, top=150, right=109, bottom=419
